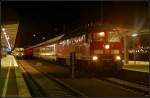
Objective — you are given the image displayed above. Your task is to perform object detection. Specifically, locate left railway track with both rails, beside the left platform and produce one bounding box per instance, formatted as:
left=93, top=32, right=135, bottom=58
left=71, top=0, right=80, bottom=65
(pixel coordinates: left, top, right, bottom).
left=18, top=61, right=85, bottom=97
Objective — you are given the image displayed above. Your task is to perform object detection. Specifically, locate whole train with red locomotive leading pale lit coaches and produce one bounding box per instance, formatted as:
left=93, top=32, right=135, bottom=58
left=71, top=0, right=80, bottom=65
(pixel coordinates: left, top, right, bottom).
left=26, top=24, right=123, bottom=71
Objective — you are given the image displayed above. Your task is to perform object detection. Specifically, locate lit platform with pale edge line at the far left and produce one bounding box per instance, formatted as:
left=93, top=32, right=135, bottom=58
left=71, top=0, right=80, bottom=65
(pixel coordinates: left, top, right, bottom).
left=0, top=55, right=31, bottom=97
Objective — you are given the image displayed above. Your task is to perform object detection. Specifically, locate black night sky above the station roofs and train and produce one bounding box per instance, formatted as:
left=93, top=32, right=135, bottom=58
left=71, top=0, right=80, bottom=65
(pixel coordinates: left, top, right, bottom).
left=2, top=1, right=148, bottom=47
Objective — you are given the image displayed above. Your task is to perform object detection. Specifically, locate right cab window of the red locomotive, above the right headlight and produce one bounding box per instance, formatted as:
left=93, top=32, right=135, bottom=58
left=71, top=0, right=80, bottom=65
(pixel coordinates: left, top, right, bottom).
left=108, top=32, right=120, bottom=42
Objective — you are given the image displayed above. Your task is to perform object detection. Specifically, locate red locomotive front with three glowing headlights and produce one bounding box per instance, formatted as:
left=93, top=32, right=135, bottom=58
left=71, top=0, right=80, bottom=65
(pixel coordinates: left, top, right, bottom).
left=90, top=30, right=123, bottom=70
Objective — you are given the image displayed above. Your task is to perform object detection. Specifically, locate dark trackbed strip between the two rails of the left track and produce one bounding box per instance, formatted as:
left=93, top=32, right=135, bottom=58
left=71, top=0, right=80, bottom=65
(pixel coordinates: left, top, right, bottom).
left=23, top=61, right=74, bottom=97
